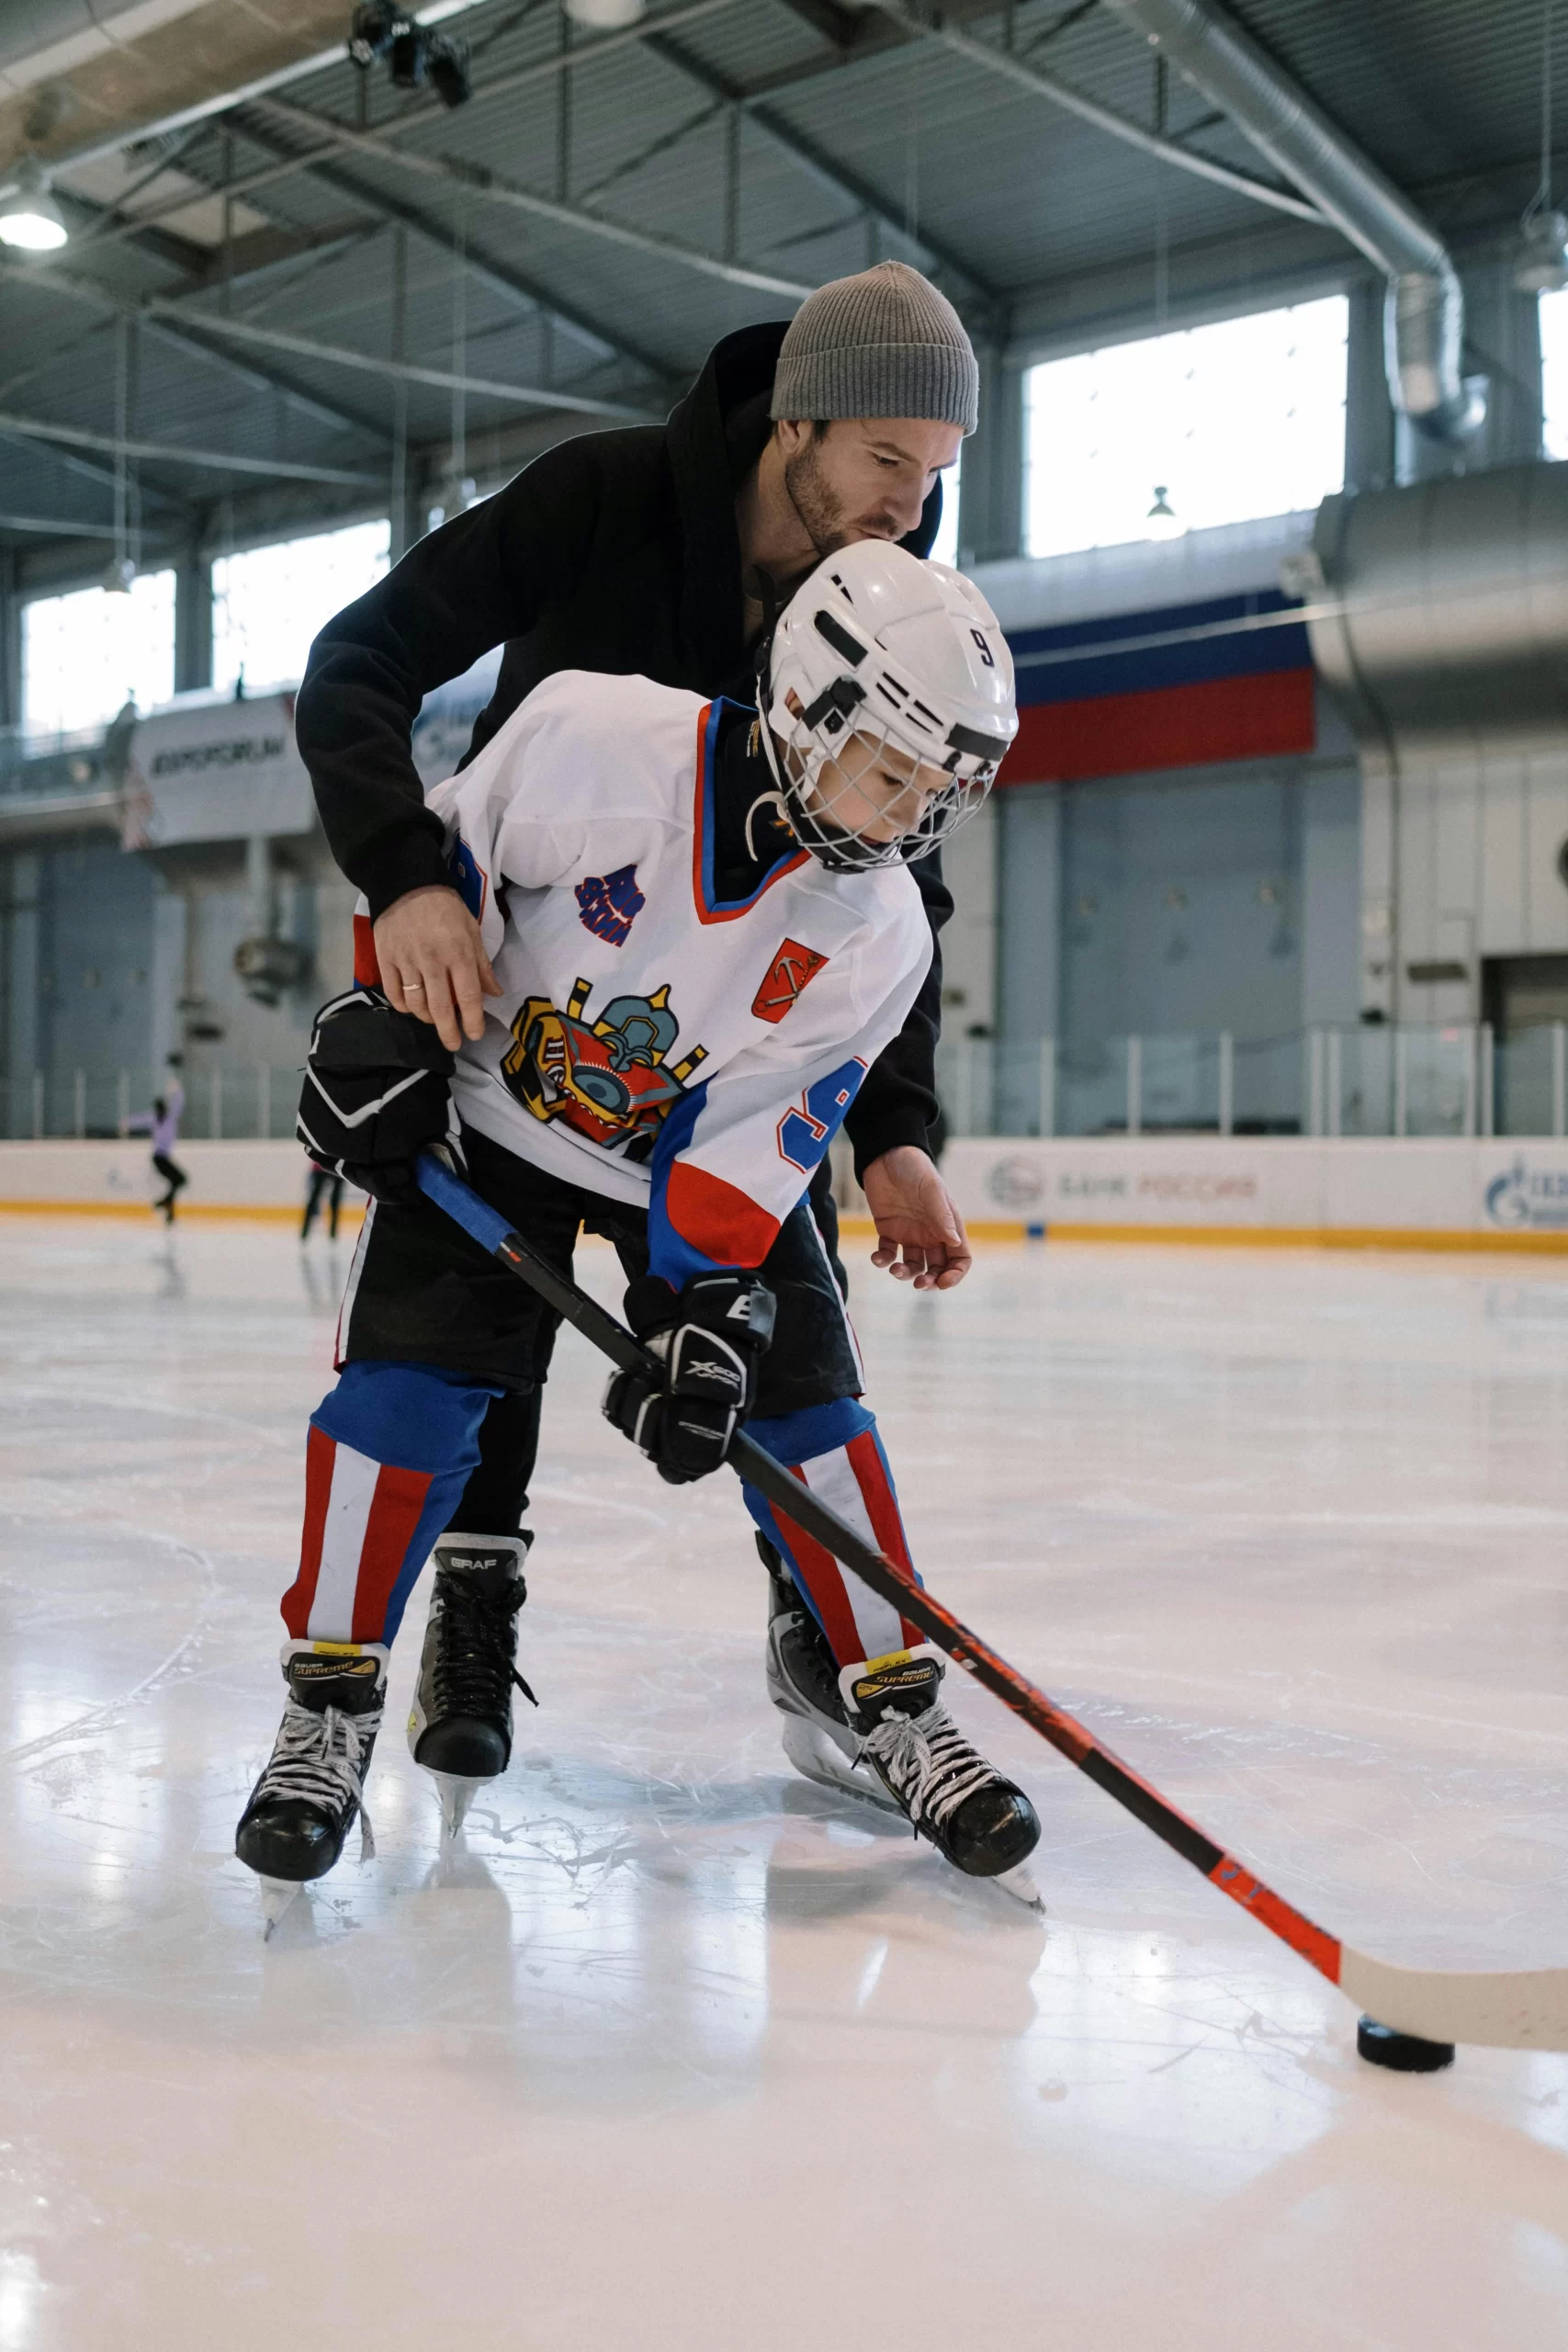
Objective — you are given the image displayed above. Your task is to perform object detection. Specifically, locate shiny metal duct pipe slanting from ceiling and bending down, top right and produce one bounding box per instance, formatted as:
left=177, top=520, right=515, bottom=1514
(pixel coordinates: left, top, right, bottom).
left=1105, top=0, right=1485, bottom=442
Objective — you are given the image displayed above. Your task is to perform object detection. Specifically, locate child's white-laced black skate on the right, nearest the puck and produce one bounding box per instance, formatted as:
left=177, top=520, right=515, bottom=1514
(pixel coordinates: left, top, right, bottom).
left=840, top=1649, right=1043, bottom=1910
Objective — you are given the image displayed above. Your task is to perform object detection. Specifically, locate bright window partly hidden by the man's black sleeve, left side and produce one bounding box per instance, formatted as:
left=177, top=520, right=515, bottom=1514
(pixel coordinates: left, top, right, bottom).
left=211, top=522, right=390, bottom=692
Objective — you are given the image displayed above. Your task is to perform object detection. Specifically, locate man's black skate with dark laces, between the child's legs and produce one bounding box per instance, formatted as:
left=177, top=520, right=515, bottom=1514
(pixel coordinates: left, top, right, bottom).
left=409, top=1533, right=538, bottom=1837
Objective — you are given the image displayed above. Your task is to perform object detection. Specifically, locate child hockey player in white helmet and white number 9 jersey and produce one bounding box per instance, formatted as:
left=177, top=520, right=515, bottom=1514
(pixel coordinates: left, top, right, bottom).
left=237, top=541, right=1039, bottom=1884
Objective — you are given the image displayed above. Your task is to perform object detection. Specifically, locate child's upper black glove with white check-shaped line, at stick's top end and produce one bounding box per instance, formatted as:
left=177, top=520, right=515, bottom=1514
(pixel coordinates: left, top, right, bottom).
left=294, top=988, right=454, bottom=1202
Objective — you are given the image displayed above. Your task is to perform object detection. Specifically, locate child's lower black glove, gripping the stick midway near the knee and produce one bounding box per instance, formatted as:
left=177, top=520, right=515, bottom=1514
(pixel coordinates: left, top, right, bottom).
left=604, top=1272, right=773, bottom=1487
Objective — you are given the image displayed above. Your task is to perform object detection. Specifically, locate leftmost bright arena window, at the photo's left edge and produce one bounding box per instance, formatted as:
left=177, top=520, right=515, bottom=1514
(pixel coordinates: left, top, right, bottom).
left=21, top=571, right=174, bottom=734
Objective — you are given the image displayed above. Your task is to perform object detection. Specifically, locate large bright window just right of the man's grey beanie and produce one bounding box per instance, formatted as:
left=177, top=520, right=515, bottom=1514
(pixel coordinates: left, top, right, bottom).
left=1025, top=294, right=1349, bottom=555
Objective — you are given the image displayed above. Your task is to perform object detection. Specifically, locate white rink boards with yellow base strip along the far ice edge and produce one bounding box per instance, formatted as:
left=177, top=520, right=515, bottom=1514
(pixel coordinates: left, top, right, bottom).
left=0, top=1136, right=1568, bottom=1251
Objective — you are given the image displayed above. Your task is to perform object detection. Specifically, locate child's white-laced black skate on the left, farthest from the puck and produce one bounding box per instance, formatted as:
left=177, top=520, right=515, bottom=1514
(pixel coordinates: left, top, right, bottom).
left=235, top=1642, right=388, bottom=1933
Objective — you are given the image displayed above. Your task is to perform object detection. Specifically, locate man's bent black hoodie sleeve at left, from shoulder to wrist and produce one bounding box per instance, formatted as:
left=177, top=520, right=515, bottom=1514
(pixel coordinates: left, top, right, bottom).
left=294, top=440, right=602, bottom=917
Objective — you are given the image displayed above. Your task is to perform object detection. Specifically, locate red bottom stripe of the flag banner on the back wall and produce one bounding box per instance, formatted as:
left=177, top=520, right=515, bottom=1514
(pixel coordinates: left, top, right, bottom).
left=999, top=671, right=1316, bottom=788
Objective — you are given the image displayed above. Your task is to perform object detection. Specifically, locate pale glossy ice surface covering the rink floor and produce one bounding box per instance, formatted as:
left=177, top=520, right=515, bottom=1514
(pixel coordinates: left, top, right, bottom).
left=0, top=1218, right=1568, bottom=2352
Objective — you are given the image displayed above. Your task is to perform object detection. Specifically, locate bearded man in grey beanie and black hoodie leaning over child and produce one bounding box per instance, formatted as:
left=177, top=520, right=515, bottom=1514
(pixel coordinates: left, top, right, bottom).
left=296, top=248, right=978, bottom=1796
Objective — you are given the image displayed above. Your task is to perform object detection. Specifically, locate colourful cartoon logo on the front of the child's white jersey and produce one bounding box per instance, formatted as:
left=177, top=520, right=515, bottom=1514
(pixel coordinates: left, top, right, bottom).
left=501, top=981, right=707, bottom=1159
